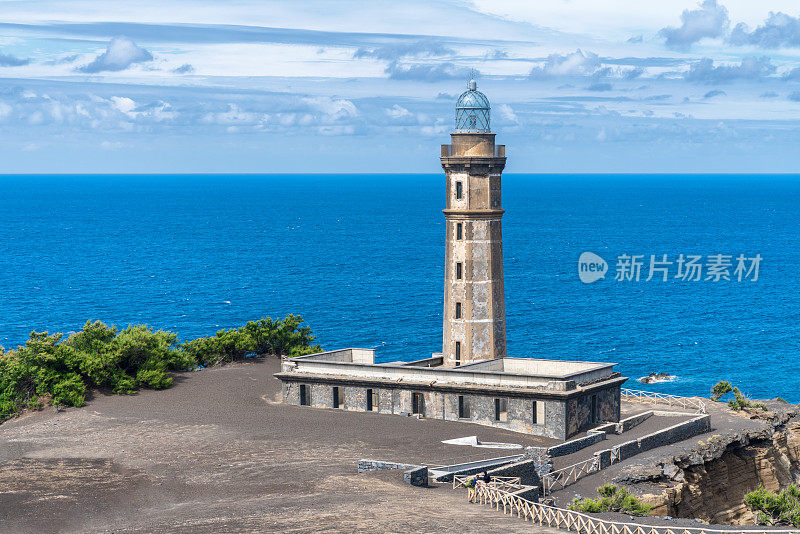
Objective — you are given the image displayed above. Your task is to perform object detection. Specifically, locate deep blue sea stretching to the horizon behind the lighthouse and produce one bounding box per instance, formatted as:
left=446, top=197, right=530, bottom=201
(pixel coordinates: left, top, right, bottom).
left=0, top=174, right=800, bottom=401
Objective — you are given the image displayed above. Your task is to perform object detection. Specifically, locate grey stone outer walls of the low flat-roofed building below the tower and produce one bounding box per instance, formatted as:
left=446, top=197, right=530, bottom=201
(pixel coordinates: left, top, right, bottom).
left=283, top=382, right=600, bottom=439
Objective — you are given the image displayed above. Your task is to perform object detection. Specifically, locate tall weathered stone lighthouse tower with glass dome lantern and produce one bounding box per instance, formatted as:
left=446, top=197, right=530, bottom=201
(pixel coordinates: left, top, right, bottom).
left=442, top=79, right=506, bottom=366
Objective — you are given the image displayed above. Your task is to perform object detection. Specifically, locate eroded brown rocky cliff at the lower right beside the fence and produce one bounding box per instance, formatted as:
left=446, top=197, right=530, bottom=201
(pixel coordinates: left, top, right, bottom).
left=617, top=402, right=800, bottom=525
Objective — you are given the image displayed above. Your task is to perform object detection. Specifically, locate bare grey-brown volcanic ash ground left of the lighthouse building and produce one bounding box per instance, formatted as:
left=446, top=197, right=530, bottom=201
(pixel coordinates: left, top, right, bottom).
left=0, top=359, right=558, bottom=533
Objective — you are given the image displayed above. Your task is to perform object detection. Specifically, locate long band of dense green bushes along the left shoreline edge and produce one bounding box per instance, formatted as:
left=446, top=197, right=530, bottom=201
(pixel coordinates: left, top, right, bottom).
left=0, top=315, right=321, bottom=421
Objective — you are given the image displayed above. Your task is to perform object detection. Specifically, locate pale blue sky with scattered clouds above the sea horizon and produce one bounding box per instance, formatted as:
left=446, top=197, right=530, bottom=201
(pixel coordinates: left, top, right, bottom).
left=0, top=0, right=800, bottom=172
